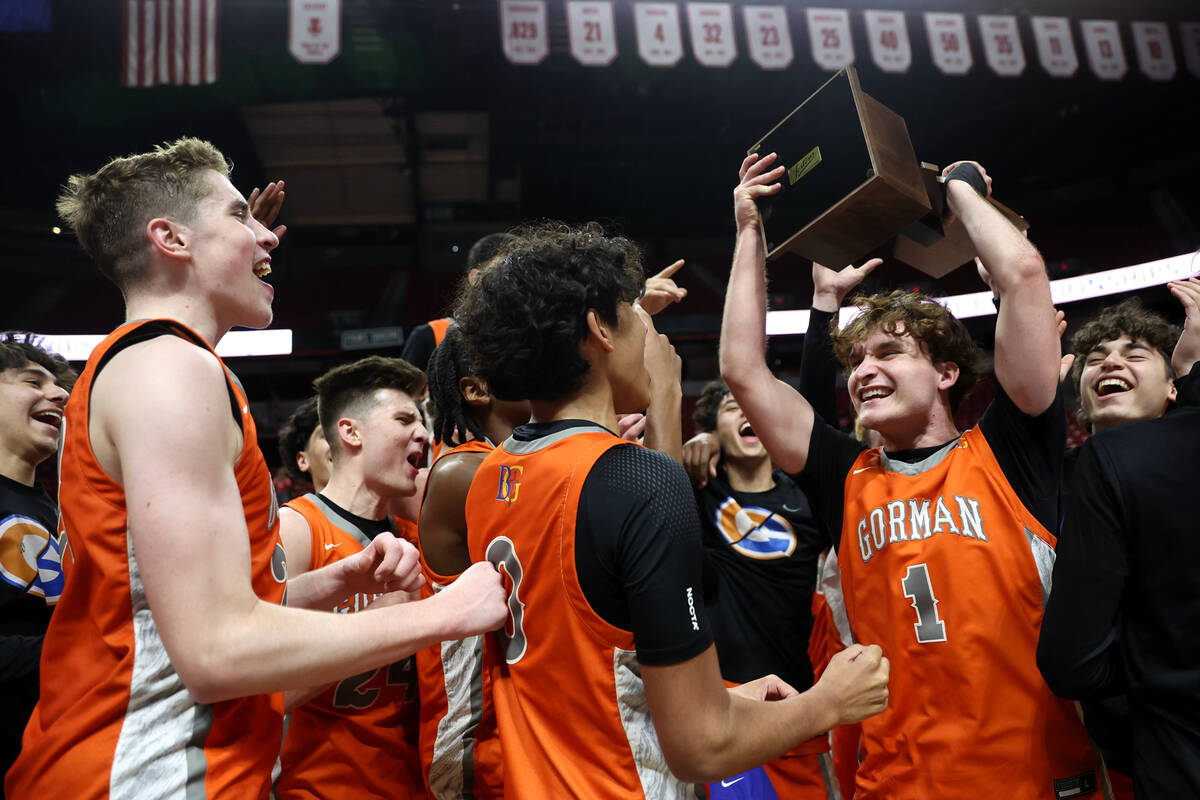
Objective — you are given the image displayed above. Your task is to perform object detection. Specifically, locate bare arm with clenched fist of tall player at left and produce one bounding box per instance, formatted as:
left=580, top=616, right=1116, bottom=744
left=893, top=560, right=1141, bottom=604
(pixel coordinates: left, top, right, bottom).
left=91, top=336, right=505, bottom=703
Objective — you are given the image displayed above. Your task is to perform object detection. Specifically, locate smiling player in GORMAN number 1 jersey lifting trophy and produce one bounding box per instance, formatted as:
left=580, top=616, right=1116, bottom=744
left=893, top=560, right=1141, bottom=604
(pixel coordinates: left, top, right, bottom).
left=720, top=154, right=1097, bottom=800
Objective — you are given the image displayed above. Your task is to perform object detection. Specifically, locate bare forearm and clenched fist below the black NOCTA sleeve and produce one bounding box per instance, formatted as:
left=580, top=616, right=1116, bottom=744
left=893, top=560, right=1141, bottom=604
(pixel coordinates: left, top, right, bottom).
left=642, top=644, right=889, bottom=783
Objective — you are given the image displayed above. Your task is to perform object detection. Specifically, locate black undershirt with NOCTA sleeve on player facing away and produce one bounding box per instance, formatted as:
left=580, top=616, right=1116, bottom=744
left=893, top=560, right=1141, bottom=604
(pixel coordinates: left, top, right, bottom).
left=512, top=420, right=713, bottom=667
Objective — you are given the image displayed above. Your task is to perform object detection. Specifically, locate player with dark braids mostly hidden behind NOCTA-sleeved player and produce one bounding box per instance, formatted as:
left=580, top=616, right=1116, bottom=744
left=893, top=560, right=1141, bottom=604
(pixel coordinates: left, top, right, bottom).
left=415, top=327, right=529, bottom=800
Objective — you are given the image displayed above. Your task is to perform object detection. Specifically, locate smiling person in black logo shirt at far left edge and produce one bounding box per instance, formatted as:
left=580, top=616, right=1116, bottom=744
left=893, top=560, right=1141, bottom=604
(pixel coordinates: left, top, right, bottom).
left=0, top=333, right=76, bottom=796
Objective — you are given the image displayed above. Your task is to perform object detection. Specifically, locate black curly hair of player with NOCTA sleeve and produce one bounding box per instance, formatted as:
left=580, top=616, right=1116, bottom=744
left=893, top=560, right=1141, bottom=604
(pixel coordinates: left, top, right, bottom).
left=454, top=223, right=646, bottom=402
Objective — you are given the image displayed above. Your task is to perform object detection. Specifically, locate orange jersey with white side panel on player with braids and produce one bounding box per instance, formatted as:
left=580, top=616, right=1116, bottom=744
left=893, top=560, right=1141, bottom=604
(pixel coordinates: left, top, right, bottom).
left=415, top=440, right=504, bottom=800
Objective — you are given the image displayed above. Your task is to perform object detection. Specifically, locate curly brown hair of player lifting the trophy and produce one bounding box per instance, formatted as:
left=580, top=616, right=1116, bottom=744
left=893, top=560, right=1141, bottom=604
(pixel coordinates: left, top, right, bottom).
left=830, top=289, right=982, bottom=411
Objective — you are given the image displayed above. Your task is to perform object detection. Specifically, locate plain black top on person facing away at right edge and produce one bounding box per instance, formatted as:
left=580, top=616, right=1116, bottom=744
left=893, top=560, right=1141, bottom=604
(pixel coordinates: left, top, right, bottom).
left=1038, top=408, right=1200, bottom=798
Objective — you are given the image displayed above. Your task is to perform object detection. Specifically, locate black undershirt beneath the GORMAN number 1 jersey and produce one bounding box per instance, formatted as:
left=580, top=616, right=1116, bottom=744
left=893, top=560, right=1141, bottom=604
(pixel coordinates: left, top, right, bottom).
left=797, top=383, right=1067, bottom=547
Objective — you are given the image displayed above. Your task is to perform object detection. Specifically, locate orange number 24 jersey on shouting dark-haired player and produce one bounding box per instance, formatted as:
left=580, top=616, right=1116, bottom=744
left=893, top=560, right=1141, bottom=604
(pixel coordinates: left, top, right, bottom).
left=276, top=494, right=425, bottom=800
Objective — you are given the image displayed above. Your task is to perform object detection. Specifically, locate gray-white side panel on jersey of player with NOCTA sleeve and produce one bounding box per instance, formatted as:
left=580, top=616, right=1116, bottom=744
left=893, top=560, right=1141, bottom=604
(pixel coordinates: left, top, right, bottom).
left=612, top=648, right=707, bottom=800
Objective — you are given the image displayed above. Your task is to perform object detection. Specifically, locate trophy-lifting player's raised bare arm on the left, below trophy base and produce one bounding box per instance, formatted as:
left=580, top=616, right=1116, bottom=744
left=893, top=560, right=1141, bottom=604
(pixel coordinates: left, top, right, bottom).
left=720, top=154, right=815, bottom=473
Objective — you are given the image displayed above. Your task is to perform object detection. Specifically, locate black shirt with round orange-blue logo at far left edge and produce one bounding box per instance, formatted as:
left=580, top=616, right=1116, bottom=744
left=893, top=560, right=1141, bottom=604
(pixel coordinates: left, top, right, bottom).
left=0, top=475, right=62, bottom=775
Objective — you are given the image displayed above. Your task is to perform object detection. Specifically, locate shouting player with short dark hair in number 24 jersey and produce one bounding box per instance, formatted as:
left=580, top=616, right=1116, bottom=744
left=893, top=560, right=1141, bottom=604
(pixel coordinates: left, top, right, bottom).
left=276, top=356, right=432, bottom=800
